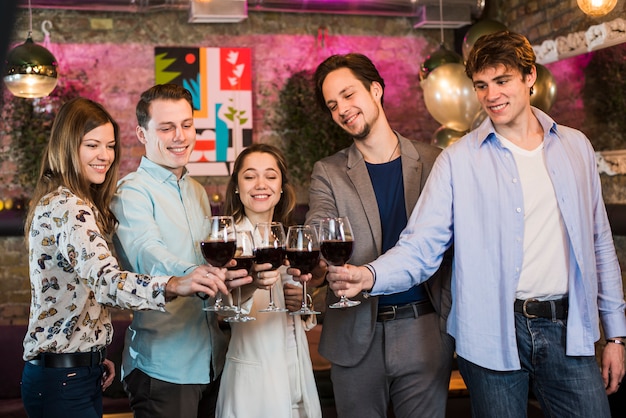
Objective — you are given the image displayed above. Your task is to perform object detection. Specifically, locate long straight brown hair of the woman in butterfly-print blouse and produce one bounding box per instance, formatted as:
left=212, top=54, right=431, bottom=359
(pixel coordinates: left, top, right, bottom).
left=24, top=97, right=121, bottom=243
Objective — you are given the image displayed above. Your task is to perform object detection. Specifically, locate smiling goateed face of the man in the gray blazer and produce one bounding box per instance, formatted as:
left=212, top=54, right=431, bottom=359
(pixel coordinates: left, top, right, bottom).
left=322, top=68, right=382, bottom=139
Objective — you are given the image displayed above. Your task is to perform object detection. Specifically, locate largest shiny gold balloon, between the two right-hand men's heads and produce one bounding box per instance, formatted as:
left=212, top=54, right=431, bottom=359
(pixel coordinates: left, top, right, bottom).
left=421, top=64, right=480, bottom=132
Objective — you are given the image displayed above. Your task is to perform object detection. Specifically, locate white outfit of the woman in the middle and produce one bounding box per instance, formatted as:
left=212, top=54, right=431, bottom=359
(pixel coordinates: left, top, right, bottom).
left=217, top=218, right=322, bottom=418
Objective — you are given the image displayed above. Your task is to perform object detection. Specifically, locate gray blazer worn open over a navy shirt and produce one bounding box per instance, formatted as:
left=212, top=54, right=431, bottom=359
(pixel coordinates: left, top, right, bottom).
left=307, top=133, right=451, bottom=367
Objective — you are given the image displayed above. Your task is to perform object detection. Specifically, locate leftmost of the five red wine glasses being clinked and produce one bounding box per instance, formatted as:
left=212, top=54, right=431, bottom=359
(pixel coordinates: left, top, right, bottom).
left=200, top=216, right=237, bottom=315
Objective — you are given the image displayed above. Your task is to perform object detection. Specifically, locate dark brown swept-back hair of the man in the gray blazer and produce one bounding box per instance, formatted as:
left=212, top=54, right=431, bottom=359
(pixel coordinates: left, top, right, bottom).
left=313, top=53, right=385, bottom=112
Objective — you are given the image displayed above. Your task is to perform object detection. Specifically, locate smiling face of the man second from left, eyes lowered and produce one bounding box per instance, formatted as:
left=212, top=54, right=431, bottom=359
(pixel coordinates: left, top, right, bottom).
left=137, top=99, right=196, bottom=178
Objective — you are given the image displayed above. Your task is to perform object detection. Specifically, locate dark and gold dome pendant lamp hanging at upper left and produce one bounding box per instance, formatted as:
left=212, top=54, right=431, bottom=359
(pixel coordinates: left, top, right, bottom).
left=4, top=0, right=58, bottom=98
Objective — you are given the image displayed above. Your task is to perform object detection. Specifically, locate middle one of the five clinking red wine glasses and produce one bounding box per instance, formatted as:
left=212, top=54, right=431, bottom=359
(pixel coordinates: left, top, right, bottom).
left=254, top=222, right=288, bottom=312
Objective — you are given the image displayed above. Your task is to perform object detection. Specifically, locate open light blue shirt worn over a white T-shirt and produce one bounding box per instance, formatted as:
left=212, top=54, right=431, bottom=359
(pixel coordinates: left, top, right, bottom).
left=370, top=108, right=626, bottom=370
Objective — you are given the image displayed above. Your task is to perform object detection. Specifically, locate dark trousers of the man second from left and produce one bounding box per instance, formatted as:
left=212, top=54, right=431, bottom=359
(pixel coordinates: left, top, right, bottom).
left=124, top=369, right=220, bottom=418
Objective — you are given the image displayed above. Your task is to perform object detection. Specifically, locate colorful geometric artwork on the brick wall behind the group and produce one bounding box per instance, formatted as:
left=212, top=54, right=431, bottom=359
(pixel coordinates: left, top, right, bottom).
left=154, top=47, right=252, bottom=176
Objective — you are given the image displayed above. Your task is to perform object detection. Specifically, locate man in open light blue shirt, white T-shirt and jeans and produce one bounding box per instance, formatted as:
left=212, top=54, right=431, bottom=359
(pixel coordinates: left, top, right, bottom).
left=327, top=32, right=626, bottom=418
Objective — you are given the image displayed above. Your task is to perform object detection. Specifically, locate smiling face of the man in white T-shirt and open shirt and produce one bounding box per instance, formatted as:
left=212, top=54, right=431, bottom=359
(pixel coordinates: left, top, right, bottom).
left=472, top=64, right=537, bottom=130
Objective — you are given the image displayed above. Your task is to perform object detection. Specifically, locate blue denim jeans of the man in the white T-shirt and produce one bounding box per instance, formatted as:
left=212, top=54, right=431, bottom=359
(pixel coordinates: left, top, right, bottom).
left=458, top=313, right=611, bottom=418
